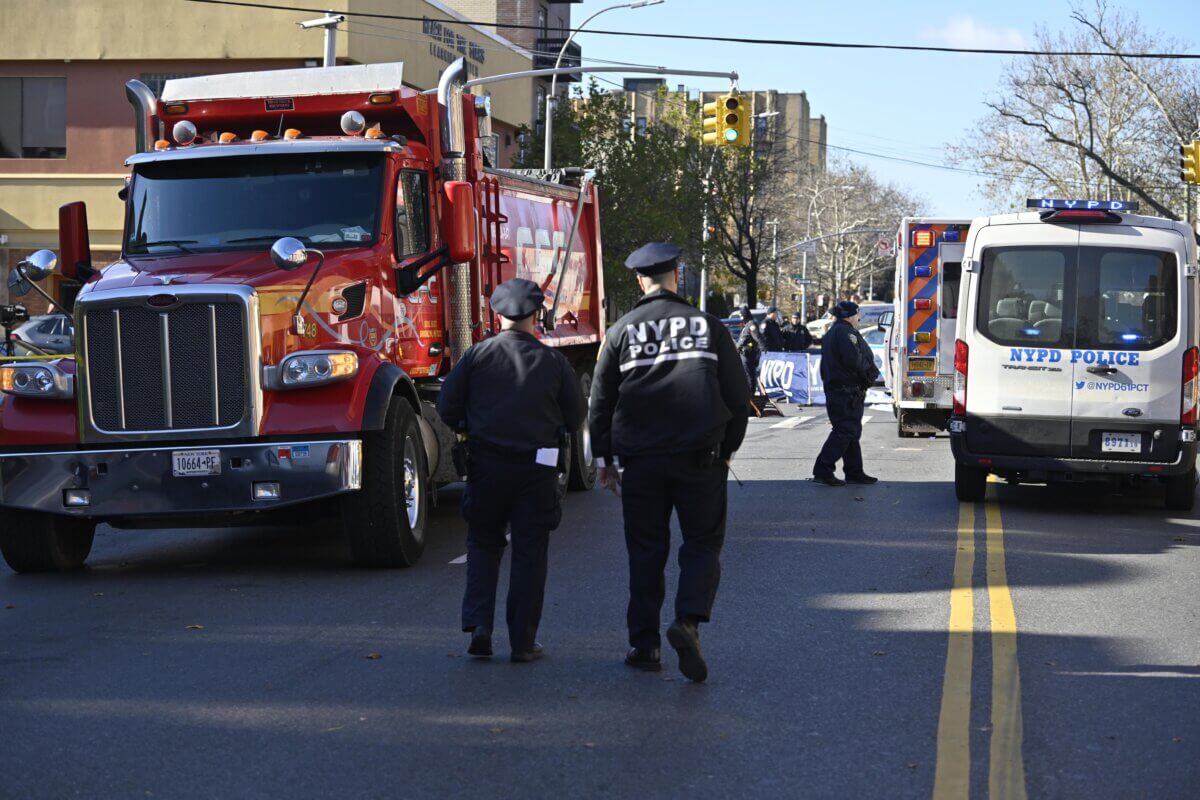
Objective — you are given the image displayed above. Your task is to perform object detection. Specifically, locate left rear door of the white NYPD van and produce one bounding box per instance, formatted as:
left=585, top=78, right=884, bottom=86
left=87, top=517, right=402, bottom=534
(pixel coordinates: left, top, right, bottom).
left=960, top=223, right=1079, bottom=458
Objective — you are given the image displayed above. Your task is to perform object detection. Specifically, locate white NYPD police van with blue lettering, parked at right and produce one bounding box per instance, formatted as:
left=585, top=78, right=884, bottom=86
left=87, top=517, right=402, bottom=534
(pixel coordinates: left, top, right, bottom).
left=950, top=200, right=1200, bottom=510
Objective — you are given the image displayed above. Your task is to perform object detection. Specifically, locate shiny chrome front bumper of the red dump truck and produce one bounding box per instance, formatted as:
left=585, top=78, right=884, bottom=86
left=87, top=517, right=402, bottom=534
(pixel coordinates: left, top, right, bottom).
left=0, top=439, right=362, bottom=519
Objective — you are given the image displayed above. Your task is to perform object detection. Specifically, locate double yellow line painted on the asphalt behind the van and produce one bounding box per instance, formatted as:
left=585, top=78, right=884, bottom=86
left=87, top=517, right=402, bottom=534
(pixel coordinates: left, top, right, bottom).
left=934, top=489, right=1026, bottom=800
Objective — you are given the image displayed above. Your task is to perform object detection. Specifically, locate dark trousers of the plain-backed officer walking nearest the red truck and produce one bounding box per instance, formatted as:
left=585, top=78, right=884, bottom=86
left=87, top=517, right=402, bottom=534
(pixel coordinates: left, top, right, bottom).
left=462, top=451, right=562, bottom=652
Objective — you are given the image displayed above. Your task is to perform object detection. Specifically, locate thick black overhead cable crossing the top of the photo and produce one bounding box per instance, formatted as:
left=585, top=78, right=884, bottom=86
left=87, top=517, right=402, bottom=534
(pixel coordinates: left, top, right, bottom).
left=180, top=0, right=1200, bottom=60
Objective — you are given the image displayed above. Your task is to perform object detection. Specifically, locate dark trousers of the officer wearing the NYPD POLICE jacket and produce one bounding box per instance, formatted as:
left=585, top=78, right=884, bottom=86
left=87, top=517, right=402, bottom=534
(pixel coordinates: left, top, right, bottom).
left=622, top=453, right=727, bottom=648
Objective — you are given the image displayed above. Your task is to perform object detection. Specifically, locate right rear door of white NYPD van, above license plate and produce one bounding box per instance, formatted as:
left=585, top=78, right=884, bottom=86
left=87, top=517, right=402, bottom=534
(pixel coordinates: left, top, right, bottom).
left=1070, top=224, right=1189, bottom=463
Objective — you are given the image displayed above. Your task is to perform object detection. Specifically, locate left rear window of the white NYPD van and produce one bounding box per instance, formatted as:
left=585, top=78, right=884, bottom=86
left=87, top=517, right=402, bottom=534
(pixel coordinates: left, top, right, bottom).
left=978, top=247, right=1075, bottom=348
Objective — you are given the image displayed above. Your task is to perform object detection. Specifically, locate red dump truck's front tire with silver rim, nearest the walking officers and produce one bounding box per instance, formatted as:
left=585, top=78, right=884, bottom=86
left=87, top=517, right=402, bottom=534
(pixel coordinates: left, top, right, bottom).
left=342, top=397, right=431, bottom=567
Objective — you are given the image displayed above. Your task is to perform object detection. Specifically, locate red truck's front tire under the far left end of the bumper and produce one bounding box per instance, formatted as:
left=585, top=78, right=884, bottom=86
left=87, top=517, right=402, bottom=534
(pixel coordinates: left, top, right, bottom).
left=0, top=509, right=96, bottom=572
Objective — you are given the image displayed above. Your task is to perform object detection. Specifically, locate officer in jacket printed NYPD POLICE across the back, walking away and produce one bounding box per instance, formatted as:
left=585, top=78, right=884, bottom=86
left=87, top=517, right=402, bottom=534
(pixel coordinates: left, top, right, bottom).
left=589, top=243, right=754, bottom=681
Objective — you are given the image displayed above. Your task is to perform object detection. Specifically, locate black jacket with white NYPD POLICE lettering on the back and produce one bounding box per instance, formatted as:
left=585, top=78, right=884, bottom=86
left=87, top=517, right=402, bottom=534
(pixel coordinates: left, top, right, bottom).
left=589, top=290, right=750, bottom=463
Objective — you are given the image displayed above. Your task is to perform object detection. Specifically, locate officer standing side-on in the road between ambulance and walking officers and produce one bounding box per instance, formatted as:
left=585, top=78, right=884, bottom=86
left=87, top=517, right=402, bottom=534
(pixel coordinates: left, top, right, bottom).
left=812, top=300, right=880, bottom=486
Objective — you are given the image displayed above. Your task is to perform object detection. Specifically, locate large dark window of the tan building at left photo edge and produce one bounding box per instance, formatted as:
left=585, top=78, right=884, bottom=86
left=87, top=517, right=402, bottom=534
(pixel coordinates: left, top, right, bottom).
left=0, top=78, right=67, bottom=158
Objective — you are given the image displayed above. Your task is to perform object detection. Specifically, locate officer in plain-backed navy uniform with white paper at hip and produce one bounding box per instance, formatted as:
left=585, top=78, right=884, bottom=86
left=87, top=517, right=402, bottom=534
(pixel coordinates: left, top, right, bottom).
left=438, top=278, right=586, bottom=662
